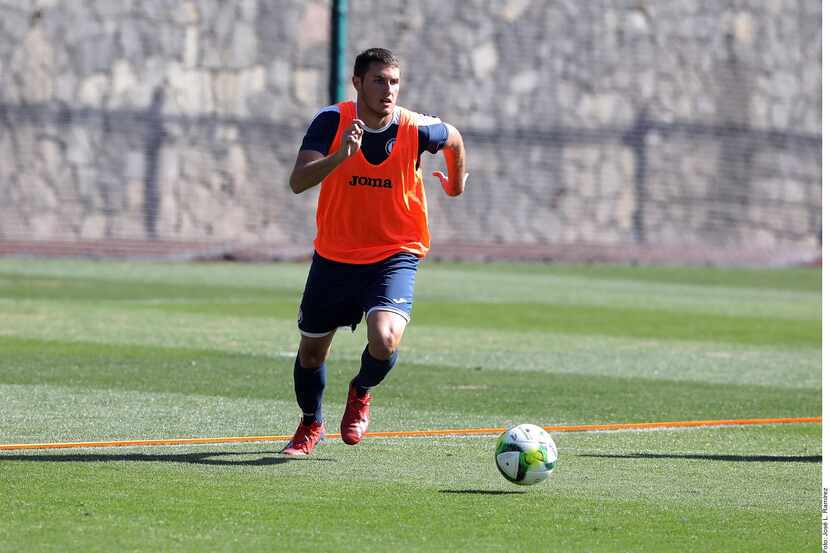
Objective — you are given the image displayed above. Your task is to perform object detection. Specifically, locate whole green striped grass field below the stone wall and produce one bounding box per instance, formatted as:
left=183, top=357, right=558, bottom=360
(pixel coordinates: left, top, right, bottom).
left=0, top=258, right=822, bottom=553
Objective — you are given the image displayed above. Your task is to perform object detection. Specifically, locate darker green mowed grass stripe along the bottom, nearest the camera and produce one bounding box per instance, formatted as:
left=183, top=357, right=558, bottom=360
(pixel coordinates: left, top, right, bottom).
left=0, top=466, right=819, bottom=553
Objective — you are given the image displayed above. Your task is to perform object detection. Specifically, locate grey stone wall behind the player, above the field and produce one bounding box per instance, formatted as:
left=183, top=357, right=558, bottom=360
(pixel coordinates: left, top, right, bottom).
left=0, top=0, right=821, bottom=260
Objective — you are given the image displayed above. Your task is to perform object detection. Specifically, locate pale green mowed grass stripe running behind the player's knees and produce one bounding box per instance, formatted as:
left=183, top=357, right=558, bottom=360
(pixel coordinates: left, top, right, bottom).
left=0, top=300, right=821, bottom=388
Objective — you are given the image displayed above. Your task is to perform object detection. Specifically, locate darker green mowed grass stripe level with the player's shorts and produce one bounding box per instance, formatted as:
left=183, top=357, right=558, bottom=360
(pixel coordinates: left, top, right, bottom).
left=0, top=273, right=821, bottom=347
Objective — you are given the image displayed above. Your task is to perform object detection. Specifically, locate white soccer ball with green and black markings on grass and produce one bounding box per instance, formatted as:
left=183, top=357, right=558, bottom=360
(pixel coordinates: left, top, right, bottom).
left=496, top=424, right=559, bottom=486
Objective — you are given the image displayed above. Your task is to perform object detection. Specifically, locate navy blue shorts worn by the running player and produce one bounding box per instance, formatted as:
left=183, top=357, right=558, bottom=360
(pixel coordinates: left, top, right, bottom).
left=297, top=252, right=419, bottom=338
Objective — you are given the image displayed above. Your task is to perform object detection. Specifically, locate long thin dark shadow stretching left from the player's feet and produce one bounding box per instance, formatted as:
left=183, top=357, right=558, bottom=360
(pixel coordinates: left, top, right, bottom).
left=0, top=451, right=334, bottom=466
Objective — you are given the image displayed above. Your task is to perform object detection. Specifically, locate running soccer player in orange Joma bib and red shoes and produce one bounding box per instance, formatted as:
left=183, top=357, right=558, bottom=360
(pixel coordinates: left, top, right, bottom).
left=282, top=48, right=467, bottom=455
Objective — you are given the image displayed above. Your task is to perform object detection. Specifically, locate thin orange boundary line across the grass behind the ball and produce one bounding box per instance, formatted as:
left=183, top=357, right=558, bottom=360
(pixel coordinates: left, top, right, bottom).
left=0, top=417, right=821, bottom=451
